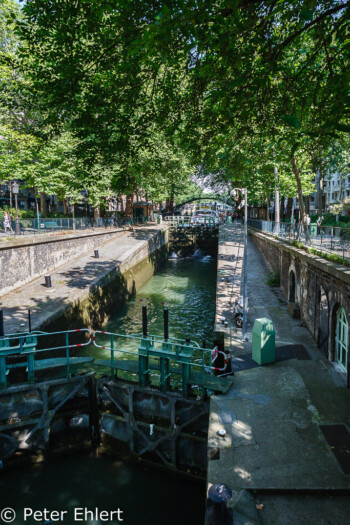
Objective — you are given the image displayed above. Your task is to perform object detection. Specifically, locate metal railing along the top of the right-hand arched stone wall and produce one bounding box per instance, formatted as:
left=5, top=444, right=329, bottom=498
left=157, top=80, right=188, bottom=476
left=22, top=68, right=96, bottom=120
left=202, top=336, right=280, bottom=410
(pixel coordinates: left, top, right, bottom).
left=248, top=219, right=350, bottom=260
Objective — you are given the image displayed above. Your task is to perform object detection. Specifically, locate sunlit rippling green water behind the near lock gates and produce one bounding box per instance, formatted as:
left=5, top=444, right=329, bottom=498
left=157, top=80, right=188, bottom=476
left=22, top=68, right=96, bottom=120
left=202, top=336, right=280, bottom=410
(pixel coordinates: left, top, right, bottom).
left=84, top=256, right=216, bottom=366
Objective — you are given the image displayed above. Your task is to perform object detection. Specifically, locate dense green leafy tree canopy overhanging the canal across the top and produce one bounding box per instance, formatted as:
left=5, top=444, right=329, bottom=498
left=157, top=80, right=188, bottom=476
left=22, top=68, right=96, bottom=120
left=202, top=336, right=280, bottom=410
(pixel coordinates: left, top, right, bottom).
left=0, top=0, right=350, bottom=213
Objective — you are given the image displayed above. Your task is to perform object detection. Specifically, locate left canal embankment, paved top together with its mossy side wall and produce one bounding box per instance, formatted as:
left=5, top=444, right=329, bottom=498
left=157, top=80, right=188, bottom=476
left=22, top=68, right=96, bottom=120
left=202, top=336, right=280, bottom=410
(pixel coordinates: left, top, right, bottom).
left=1, top=225, right=168, bottom=333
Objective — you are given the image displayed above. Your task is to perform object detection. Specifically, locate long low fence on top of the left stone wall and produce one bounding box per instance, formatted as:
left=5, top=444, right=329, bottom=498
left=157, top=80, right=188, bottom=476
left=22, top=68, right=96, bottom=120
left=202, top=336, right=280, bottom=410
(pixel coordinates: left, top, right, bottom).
left=1, top=217, right=150, bottom=235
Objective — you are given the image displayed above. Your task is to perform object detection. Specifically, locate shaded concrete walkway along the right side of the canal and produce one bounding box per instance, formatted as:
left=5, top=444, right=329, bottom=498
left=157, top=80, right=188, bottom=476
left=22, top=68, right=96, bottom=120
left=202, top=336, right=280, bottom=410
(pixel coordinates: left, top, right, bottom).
left=208, top=225, right=350, bottom=525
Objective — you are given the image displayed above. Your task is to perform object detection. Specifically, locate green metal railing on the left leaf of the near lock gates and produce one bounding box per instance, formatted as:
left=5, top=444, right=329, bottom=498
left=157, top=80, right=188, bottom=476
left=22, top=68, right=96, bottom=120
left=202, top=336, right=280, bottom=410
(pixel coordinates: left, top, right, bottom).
left=0, top=328, right=93, bottom=389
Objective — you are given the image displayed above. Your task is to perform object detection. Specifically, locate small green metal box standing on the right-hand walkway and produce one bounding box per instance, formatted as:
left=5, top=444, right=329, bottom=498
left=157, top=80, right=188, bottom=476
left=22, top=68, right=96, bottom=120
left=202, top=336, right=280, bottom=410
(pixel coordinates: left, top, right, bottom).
left=252, top=317, right=276, bottom=365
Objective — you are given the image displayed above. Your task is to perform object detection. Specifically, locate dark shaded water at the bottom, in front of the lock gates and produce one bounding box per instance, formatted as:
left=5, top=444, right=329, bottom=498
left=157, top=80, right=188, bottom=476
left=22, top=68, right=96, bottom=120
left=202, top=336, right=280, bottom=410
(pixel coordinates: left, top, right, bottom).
left=0, top=454, right=205, bottom=525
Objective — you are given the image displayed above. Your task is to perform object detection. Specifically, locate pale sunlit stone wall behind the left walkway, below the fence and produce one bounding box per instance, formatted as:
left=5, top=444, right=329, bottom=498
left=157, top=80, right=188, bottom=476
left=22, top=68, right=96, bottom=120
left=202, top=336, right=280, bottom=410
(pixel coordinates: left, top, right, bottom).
left=0, top=228, right=123, bottom=295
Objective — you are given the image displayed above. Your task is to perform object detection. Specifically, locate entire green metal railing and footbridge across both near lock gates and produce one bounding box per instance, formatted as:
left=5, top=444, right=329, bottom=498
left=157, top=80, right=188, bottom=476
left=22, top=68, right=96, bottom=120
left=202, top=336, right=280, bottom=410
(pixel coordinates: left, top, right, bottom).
left=0, top=328, right=227, bottom=396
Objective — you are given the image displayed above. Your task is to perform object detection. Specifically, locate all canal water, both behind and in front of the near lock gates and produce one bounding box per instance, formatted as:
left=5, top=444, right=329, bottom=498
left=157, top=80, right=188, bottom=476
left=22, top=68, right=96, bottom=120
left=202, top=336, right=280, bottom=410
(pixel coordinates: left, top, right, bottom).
left=0, top=253, right=216, bottom=525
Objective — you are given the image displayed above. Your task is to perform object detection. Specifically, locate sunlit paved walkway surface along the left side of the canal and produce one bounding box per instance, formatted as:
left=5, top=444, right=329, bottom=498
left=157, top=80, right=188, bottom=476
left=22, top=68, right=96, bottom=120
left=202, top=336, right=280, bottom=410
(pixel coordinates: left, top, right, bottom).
left=0, top=225, right=164, bottom=334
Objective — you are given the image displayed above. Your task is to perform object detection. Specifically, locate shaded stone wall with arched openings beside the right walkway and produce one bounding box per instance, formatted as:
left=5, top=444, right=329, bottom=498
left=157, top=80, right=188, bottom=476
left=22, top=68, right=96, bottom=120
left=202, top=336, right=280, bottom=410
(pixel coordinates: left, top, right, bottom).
left=250, top=229, right=350, bottom=361
